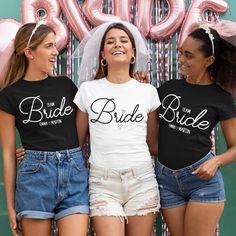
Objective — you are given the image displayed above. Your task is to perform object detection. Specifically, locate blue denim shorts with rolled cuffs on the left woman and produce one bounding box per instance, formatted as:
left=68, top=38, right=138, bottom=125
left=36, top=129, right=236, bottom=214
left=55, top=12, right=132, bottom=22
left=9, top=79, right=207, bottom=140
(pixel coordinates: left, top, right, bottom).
left=15, top=148, right=89, bottom=220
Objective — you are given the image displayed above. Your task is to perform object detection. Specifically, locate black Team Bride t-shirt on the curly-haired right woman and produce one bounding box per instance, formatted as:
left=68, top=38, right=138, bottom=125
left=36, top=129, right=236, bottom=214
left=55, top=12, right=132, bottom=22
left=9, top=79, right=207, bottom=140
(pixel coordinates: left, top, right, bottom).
left=158, top=79, right=236, bottom=170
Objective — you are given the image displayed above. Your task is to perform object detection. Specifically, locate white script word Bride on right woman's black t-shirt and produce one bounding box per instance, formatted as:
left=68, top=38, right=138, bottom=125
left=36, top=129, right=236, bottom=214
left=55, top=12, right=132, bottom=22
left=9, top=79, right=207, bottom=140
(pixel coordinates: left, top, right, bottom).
left=159, top=94, right=209, bottom=130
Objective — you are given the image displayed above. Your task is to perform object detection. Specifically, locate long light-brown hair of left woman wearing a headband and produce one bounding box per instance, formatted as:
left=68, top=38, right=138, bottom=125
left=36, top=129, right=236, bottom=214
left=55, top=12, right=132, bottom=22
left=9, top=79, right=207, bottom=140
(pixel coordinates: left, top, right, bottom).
left=3, top=23, right=55, bottom=87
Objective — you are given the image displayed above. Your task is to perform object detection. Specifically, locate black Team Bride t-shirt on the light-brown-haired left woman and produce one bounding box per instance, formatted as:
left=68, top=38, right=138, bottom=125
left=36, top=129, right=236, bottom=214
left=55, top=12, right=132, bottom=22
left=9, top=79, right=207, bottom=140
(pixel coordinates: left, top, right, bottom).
left=0, top=76, right=79, bottom=151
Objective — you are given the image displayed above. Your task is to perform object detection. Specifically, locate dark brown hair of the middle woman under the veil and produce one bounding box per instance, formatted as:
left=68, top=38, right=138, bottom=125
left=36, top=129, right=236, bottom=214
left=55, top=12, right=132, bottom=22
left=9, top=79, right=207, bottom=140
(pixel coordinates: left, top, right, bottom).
left=95, top=23, right=136, bottom=79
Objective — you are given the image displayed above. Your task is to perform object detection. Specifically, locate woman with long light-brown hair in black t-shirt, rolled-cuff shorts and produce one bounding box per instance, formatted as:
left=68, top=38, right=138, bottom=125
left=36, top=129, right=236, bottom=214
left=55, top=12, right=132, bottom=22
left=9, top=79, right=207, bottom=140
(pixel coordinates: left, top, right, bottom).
left=0, top=21, right=89, bottom=236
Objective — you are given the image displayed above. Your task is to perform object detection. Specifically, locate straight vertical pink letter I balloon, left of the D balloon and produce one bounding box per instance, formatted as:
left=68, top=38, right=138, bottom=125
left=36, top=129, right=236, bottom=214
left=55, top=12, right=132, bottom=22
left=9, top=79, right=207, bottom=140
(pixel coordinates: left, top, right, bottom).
left=136, top=0, right=152, bottom=37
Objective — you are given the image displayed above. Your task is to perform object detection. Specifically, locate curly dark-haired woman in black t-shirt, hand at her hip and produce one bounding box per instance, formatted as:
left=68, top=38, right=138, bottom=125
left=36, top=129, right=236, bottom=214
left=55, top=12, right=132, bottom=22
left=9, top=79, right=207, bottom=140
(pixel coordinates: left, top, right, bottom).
left=156, top=23, right=236, bottom=236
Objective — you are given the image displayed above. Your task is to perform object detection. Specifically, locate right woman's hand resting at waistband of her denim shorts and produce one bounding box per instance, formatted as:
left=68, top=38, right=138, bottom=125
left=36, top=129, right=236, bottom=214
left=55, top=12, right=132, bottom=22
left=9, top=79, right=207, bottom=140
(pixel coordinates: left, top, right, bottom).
left=192, top=156, right=219, bottom=180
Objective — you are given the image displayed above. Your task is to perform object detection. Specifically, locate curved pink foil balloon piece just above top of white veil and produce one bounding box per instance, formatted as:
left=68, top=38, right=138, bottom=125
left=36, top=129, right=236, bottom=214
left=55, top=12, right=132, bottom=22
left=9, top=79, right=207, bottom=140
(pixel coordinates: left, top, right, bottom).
left=83, top=0, right=121, bottom=26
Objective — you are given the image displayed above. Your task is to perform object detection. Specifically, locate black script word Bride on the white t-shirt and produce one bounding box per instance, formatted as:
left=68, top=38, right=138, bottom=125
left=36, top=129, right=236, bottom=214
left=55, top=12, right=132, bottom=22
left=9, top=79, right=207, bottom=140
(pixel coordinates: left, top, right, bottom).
left=91, top=98, right=144, bottom=124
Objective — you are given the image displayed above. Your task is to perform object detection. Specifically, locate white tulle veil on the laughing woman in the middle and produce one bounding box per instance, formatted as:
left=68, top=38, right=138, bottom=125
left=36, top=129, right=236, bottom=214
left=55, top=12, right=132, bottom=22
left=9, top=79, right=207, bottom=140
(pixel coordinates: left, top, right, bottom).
left=73, top=21, right=148, bottom=87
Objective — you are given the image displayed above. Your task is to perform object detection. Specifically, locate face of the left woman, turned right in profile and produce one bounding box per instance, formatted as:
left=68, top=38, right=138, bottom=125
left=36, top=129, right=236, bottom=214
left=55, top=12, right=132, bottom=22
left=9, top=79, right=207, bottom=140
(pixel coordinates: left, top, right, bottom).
left=30, top=32, right=58, bottom=73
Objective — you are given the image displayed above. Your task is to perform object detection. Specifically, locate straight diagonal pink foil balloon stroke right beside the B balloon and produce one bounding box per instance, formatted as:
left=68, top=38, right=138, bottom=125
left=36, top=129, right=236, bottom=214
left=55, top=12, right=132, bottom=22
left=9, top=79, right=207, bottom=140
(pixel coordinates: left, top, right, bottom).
left=58, top=0, right=89, bottom=41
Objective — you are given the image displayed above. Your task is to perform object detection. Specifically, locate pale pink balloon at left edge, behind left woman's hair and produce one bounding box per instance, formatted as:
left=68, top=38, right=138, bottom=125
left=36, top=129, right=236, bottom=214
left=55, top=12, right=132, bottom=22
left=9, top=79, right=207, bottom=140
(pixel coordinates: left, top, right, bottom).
left=0, top=19, right=22, bottom=87
